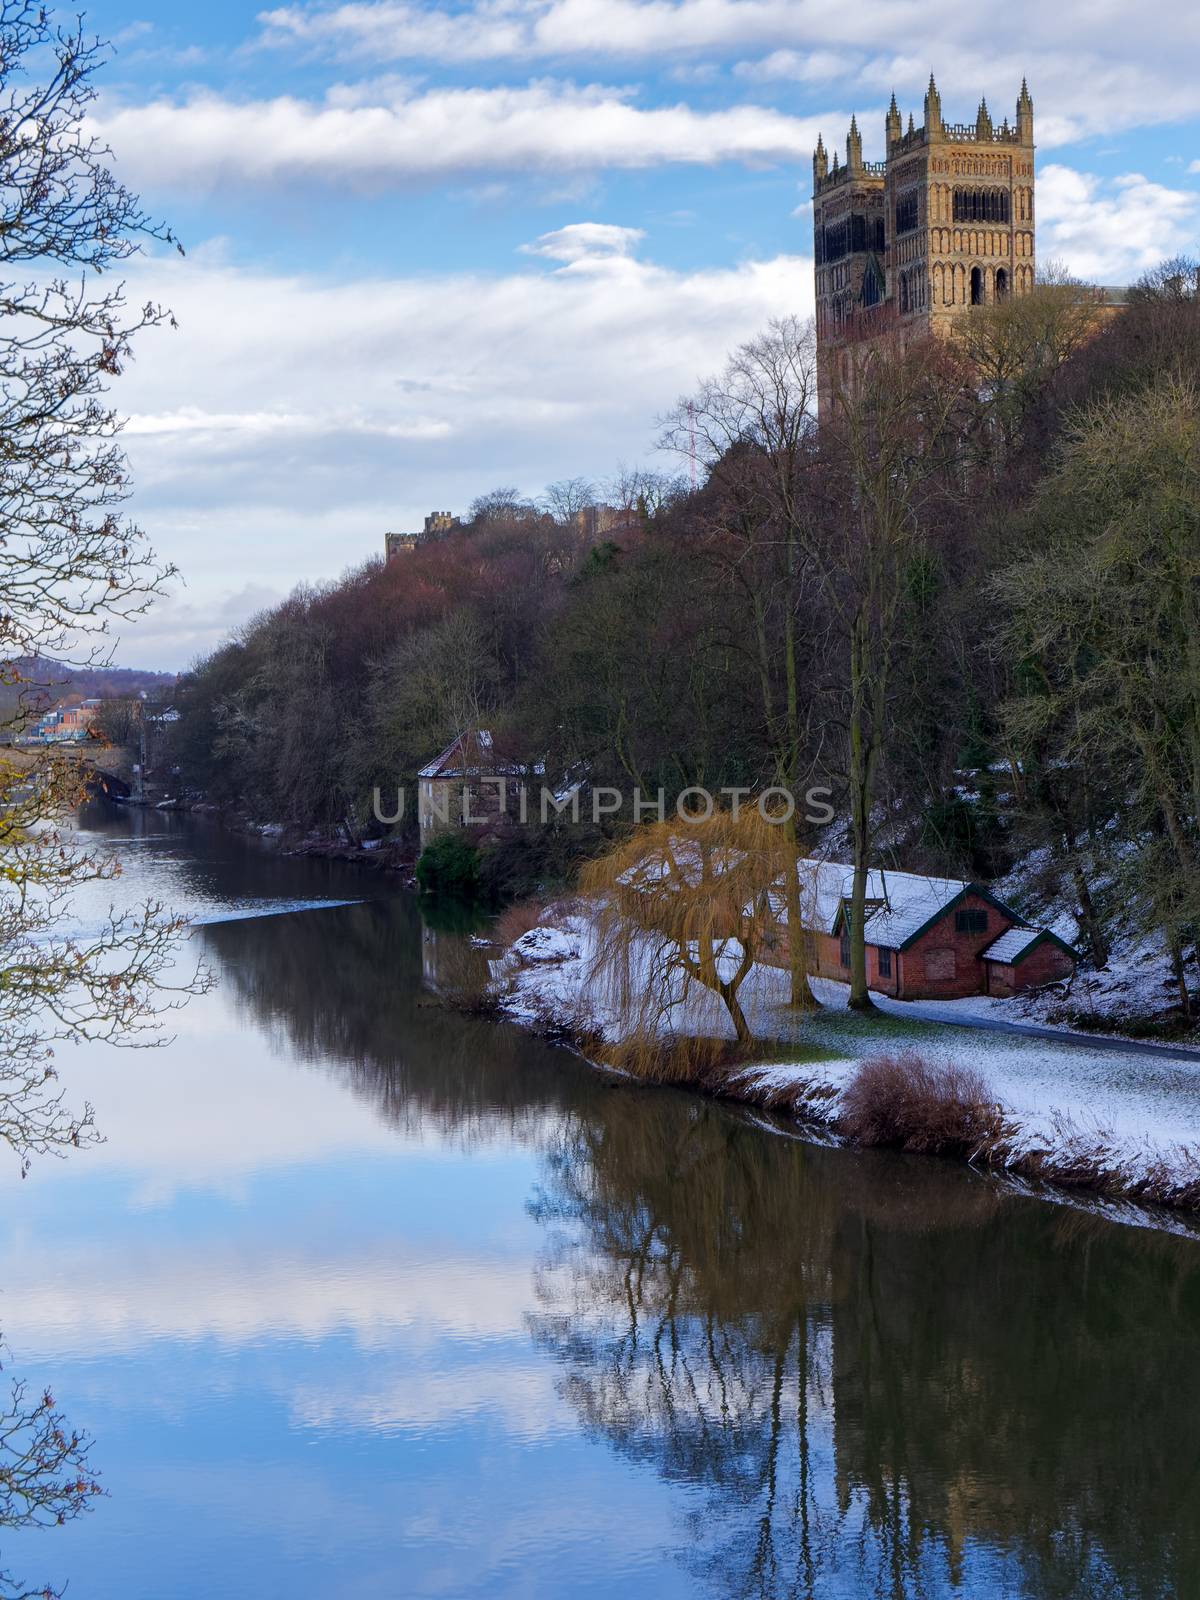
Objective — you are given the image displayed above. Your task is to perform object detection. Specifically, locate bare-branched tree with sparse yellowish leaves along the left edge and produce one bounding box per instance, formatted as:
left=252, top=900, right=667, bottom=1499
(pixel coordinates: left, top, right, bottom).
left=0, top=0, right=200, bottom=1166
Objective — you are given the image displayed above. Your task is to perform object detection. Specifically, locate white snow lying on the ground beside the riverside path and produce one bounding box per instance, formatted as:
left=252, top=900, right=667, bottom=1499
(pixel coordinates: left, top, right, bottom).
left=491, top=912, right=1200, bottom=1203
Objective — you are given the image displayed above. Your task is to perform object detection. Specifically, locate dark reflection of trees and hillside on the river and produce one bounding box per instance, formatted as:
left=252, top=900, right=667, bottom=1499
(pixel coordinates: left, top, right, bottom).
left=205, top=902, right=1200, bottom=1600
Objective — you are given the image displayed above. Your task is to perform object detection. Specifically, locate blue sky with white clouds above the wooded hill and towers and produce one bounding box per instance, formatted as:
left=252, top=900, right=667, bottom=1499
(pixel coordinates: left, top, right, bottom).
left=72, top=0, right=1200, bottom=667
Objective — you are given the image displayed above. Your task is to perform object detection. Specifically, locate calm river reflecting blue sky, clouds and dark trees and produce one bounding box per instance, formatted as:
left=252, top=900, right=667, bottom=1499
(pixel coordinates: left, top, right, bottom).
left=0, top=813, right=1200, bottom=1600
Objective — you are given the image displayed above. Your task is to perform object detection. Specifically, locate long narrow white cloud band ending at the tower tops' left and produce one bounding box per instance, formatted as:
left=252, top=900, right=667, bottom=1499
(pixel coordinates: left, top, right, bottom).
left=93, top=82, right=840, bottom=190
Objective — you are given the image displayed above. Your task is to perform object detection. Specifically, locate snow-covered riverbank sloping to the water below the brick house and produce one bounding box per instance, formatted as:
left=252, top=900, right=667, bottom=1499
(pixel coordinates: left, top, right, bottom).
left=493, top=909, right=1200, bottom=1208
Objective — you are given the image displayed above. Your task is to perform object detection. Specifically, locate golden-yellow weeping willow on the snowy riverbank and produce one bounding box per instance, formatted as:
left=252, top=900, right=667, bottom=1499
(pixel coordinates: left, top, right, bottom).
left=579, top=806, right=805, bottom=1070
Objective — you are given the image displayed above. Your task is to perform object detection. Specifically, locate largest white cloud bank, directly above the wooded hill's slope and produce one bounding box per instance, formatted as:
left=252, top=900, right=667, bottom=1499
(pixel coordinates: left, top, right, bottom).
left=101, top=235, right=813, bottom=667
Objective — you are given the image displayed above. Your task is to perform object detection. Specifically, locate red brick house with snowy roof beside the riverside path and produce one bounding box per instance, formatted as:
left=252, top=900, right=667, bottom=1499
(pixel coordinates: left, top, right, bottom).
left=800, top=861, right=1075, bottom=1000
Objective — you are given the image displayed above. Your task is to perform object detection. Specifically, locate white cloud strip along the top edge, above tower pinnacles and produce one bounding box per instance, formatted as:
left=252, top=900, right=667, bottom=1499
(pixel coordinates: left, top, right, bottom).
left=261, top=0, right=1200, bottom=146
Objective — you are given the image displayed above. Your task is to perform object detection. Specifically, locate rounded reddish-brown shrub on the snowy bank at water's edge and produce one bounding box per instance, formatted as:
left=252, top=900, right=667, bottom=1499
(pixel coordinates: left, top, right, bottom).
left=837, top=1050, right=1006, bottom=1155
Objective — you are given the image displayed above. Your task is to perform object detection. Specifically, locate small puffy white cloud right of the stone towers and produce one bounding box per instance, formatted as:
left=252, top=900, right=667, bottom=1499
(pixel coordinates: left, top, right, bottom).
left=1037, top=166, right=1200, bottom=283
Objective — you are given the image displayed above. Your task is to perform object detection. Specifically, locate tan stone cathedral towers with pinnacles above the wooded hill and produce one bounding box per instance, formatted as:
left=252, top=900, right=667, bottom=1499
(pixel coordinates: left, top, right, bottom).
left=813, top=77, right=1034, bottom=403
